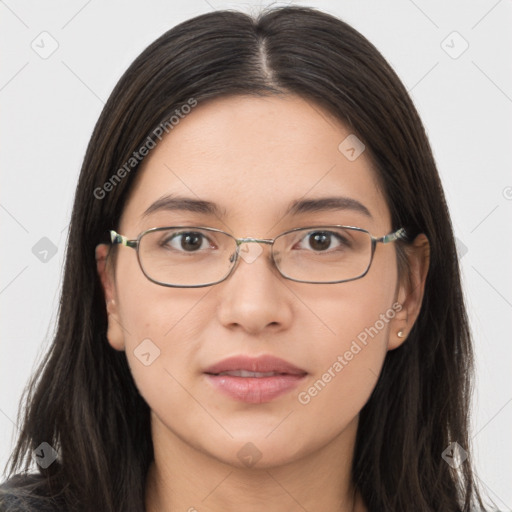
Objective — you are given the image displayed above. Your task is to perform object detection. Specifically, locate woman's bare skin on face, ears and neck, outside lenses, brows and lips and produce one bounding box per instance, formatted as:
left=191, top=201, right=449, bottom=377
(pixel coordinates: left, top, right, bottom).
left=96, top=95, right=428, bottom=512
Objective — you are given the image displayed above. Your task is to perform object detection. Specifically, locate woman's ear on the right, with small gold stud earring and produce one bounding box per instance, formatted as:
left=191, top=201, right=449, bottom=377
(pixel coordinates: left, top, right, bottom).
left=388, top=233, right=430, bottom=350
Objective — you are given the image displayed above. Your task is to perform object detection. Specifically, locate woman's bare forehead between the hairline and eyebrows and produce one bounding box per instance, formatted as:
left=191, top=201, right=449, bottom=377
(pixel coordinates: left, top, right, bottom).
left=121, top=95, right=389, bottom=233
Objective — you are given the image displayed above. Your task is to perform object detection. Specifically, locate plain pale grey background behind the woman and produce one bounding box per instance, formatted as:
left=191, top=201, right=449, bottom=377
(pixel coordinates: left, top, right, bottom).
left=0, top=0, right=512, bottom=510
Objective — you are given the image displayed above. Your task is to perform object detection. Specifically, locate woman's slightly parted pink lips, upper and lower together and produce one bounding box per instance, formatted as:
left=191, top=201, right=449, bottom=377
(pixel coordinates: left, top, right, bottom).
left=204, top=356, right=307, bottom=404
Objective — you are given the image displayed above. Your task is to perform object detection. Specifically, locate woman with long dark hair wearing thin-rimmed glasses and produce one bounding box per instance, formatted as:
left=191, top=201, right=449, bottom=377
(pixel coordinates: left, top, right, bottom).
left=3, top=7, right=483, bottom=512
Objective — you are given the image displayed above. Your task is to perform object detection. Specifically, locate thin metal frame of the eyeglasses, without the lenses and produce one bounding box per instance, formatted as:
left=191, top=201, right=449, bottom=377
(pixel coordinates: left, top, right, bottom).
left=109, top=225, right=407, bottom=288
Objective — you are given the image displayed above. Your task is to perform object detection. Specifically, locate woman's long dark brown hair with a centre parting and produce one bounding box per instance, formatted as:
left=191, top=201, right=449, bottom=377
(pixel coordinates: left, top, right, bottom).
left=1, top=7, right=483, bottom=512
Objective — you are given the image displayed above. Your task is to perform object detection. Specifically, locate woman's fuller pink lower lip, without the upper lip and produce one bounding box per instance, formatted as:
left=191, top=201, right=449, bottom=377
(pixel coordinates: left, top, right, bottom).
left=206, top=374, right=305, bottom=404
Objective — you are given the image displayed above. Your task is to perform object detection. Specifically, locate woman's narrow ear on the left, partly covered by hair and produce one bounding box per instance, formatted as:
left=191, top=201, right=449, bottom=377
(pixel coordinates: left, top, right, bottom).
left=96, top=244, right=125, bottom=350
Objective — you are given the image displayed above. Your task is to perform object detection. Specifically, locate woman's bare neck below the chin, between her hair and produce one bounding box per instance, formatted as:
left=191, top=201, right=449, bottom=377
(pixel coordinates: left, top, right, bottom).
left=146, top=416, right=365, bottom=512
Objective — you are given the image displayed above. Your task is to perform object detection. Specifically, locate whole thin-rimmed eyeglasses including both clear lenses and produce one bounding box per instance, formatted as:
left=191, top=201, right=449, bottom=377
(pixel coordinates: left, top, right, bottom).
left=110, top=225, right=406, bottom=288
